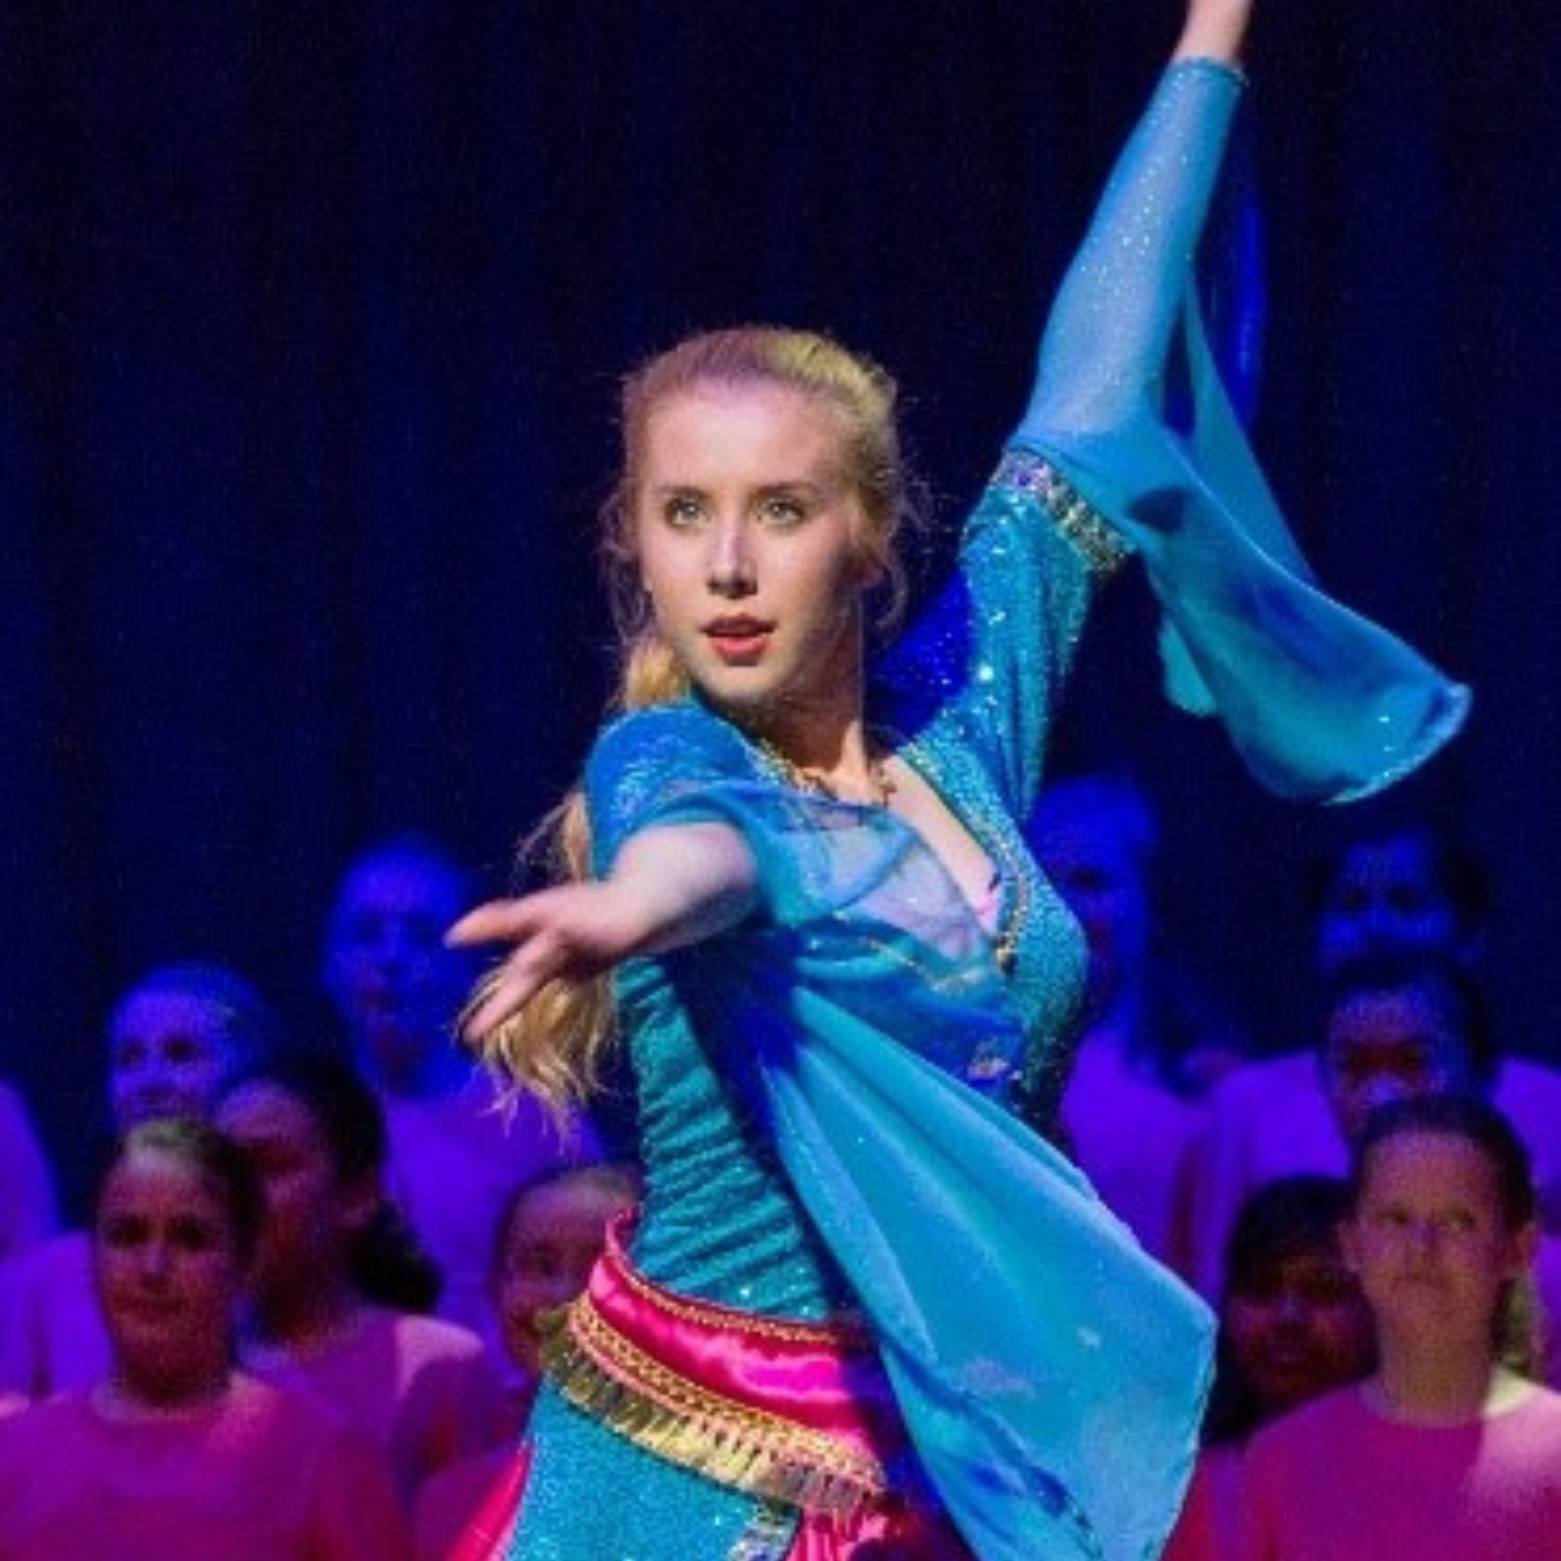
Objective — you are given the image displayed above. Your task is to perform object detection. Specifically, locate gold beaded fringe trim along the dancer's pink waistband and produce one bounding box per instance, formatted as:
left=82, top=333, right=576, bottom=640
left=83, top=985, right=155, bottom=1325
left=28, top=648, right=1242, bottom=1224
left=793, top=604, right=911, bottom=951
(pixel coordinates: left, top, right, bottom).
left=542, top=1294, right=888, bottom=1520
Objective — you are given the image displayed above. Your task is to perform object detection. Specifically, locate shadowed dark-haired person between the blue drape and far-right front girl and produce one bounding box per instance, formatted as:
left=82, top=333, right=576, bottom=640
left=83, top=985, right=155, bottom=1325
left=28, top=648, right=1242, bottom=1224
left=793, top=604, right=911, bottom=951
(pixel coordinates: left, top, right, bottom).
left=1165, top=1175, right=1377, bottom=1561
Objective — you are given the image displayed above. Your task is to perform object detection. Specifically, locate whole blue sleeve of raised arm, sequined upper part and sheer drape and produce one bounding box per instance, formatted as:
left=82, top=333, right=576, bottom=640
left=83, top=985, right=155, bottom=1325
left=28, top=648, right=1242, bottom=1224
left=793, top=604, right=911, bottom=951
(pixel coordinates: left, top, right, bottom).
left=879, top=61, right=1469, bottom=816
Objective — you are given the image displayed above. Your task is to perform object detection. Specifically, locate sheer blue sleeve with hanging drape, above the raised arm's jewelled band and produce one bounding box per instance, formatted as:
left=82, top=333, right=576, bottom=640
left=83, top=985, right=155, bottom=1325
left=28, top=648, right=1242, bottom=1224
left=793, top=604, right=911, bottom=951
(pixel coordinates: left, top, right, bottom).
left=1013, top=61, right=1467, bottom=801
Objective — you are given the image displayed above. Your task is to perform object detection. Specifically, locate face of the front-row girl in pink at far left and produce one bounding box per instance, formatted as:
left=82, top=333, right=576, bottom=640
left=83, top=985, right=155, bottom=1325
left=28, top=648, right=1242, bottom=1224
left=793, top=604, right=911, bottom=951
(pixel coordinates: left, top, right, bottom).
left=92, top=1149, right=245, bottom=1397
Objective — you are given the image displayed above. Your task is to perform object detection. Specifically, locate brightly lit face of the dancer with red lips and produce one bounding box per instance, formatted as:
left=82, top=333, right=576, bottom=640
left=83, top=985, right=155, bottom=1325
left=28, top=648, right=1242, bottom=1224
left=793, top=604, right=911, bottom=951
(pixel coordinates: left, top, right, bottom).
left=634, top=381, right=873, bottom=729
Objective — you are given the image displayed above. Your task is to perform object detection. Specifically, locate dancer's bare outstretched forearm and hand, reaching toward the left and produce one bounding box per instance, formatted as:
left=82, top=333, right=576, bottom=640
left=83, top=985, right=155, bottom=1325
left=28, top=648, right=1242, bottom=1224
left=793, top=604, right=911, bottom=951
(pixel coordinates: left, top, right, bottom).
left=448, top=823, right=759, bottom=1043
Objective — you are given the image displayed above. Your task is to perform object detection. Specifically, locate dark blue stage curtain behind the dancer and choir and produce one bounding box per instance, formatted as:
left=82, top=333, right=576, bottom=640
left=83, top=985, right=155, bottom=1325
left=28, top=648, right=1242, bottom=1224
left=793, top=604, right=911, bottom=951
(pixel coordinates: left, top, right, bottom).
left=0, top=0, right=1561, bottom=1211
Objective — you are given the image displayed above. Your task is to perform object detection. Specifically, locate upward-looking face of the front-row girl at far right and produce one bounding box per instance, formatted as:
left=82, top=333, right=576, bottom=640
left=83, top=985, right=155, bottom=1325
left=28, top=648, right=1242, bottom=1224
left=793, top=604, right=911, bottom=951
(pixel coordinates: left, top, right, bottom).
left=1344, top=1132, right=1538, bottom=1349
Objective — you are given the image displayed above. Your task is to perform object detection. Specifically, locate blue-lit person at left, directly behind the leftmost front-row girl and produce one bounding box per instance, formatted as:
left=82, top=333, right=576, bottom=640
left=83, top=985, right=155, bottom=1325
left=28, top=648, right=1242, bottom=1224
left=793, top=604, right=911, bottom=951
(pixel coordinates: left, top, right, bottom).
left=0, top=962, right=279, bottom=1399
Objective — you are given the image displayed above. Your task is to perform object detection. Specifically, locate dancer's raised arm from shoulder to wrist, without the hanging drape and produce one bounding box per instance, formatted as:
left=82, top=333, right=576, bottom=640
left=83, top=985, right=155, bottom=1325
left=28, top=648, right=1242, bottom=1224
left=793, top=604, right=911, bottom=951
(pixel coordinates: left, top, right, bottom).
left=880, top=9, right=1249, bottom=815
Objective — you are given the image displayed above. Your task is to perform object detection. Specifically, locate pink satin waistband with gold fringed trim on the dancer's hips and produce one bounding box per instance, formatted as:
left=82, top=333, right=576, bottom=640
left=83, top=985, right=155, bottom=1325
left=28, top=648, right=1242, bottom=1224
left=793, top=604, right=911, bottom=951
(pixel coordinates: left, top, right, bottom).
left=542, top=1216, right=905, bottom=1519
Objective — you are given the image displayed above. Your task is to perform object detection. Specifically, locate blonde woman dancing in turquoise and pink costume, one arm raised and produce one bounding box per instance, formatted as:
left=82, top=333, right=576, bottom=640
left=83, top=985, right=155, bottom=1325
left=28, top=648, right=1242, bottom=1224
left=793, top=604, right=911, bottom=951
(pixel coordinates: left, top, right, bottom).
left=451, top=0, right=1461, bottom=1561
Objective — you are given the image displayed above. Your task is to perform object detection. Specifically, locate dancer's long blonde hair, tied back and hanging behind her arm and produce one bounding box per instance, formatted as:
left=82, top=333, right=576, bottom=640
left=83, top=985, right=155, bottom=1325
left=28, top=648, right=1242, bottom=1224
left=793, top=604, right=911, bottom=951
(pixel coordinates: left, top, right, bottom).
left=479, top=326, right=919, bottom=1115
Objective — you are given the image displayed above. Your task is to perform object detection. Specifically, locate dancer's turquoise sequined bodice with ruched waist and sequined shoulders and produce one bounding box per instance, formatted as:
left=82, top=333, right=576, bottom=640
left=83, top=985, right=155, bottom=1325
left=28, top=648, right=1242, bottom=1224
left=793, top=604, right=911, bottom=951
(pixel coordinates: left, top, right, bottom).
left=588, top=468, right=1094, bottom=1317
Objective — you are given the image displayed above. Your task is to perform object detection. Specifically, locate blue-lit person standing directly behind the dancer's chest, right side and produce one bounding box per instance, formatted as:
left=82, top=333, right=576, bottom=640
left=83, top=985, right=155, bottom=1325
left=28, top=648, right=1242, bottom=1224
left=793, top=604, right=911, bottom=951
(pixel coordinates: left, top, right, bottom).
left=1026, top=774, right=1246, bottom=1258
